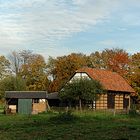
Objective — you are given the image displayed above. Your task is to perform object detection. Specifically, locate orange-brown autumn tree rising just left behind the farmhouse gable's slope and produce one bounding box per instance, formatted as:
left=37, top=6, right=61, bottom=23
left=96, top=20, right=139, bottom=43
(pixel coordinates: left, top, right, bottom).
left=47, top=53, right=87, bottom=92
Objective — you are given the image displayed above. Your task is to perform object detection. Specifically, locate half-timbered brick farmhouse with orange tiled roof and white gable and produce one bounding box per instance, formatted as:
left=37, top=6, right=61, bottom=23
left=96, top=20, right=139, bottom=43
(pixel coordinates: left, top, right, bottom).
left=70, top=68, right=135, bottom=109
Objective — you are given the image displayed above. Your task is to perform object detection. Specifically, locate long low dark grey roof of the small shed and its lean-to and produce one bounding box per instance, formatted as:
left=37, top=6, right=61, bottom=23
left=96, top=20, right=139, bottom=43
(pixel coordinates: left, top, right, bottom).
left=5, top=91, right=58, bottom=99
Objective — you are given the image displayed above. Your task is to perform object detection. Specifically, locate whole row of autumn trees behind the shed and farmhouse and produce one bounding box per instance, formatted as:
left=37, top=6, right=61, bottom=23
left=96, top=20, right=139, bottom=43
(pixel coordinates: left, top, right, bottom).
left=0, top=48, right=140, bottom=98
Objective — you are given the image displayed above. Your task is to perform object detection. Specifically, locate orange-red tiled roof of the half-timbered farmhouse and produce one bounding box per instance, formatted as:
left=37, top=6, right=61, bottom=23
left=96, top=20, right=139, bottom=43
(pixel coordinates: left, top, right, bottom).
left=76, top=68, right=135, bottom=93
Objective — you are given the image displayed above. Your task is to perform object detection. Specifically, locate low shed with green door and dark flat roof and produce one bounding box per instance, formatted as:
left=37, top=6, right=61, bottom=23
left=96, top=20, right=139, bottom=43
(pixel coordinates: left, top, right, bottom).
left=5, top=91, right=58, bottom=114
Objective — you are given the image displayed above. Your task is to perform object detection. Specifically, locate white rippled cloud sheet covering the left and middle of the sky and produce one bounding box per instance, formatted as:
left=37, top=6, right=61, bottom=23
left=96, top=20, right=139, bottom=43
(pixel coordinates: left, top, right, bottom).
left=0, top=0, right=132, bottom=57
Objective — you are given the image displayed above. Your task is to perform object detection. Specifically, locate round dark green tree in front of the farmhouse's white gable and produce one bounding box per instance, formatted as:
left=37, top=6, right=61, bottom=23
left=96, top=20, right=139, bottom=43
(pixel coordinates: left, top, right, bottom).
left=59, top=78, right=104, bottom=110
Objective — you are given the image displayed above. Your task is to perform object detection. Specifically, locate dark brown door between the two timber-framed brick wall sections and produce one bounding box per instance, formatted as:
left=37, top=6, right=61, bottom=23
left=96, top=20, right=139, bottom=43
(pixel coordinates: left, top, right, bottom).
left=107, top=94, right=115, bottom=109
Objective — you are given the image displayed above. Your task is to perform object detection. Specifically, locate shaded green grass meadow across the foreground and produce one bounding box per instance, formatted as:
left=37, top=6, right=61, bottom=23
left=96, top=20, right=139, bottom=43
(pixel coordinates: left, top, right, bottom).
left=0, top=112, right=140, bottom=140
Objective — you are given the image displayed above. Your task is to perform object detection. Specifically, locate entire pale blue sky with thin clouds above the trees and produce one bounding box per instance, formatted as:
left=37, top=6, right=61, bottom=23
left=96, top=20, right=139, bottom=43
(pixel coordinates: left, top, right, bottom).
left=0, top=0, right=140, bottom=59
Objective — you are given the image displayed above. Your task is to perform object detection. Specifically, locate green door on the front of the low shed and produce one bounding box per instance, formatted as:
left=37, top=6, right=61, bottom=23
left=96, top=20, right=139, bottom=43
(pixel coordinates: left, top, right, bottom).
left=18, top=99, right=32, bottom=114
